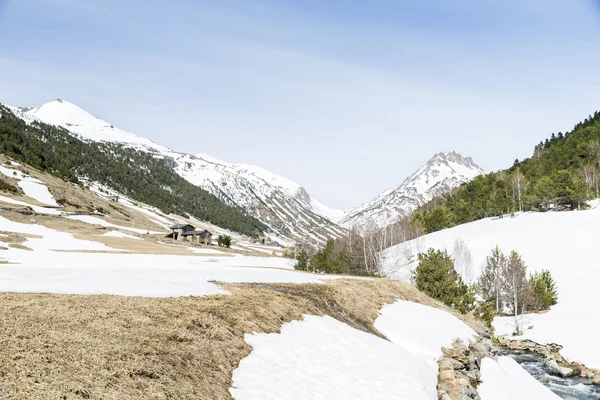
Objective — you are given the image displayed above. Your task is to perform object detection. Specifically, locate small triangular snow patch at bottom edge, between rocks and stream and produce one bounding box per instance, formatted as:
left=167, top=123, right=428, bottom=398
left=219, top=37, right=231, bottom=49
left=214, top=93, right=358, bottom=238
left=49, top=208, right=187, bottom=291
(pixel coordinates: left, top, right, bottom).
left=477, top=357, right=560, bottom=400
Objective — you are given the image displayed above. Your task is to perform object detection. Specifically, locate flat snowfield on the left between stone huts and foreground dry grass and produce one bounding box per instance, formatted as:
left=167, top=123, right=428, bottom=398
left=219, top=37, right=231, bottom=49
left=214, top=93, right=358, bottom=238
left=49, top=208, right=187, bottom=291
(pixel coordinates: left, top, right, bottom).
left=0, top=217, right=335, bottom=297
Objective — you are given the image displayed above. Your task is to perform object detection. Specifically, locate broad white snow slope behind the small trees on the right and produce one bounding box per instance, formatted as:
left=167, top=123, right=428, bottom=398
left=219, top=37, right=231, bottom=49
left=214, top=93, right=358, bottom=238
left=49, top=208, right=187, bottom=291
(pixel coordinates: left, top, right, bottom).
left=383, top=208, right=600, bottom=368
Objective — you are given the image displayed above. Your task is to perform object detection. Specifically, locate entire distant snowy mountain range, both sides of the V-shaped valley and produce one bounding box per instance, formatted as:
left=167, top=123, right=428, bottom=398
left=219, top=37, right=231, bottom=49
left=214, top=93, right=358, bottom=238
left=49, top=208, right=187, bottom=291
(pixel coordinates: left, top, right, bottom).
left=7, top=99, right=483, bottom=244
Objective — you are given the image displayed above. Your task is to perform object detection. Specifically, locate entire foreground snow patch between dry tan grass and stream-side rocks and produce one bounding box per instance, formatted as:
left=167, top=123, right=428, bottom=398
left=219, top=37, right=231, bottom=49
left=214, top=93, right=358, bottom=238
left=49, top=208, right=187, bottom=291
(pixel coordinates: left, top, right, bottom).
left=231, top=301, right=475, bottom=400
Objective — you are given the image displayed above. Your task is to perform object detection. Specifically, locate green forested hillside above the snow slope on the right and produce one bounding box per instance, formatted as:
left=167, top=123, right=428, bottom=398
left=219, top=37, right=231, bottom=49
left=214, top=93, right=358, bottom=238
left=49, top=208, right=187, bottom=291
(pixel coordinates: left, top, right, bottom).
left=418, top=112, right=600, bottom=232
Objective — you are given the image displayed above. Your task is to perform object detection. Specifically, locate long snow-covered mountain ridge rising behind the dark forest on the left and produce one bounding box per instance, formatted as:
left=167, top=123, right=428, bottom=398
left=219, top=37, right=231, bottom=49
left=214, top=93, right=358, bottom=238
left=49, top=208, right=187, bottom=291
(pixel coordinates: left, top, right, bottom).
left=9, top=99, right=343, bottom=242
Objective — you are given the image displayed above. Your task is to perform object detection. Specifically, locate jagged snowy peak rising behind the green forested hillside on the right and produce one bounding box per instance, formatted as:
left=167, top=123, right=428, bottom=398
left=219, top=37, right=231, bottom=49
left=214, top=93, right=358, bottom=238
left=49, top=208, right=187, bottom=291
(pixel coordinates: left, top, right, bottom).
left=339, top=151, right=483, bottom=229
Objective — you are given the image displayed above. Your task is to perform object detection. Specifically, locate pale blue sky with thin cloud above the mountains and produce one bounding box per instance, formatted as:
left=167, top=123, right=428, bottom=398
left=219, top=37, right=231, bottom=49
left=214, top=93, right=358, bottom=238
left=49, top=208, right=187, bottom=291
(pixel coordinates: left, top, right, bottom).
left=0, top=0, right=600, bottom=209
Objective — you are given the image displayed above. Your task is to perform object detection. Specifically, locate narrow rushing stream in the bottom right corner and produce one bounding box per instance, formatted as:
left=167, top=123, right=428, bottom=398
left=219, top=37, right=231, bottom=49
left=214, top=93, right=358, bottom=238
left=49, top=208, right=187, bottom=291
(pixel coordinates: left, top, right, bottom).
left=501, top=350, right=600, bottom=400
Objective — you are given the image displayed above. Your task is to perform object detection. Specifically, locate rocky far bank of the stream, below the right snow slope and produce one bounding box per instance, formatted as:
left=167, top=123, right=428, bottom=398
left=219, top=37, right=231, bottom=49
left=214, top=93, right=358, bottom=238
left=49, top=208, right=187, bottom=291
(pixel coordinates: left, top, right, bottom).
left=496, top=335, right=600, bottom=385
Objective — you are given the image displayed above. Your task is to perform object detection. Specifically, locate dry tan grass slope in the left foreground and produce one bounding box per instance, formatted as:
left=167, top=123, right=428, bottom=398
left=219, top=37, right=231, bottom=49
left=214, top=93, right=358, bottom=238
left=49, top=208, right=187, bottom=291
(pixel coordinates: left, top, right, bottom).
left=0, top=279, right=482, bottom=399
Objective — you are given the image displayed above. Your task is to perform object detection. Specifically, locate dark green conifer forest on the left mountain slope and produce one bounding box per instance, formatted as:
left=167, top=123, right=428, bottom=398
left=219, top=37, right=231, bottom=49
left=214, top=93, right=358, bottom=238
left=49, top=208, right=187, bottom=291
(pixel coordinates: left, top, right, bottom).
left=0, top=105, right=267, bottom=237
